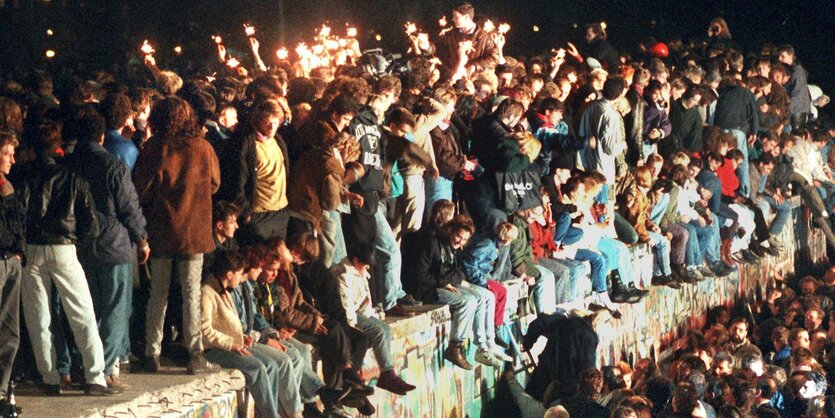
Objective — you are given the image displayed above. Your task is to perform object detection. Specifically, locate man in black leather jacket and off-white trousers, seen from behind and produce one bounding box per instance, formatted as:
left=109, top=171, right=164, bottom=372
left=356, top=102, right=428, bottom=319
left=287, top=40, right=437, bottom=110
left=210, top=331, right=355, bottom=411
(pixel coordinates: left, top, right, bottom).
left=15, top=121, right=119, bottom=396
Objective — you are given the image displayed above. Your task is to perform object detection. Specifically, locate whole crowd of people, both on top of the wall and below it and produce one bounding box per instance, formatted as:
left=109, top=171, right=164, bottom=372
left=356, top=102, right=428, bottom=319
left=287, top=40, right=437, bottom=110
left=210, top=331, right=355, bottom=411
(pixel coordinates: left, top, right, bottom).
left=0, top=3, right=835, bottom=417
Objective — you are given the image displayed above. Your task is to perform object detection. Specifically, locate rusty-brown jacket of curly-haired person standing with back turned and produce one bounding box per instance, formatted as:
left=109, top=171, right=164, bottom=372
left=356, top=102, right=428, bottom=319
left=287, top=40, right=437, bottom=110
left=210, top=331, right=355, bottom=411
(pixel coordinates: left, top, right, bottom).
left=133, top=137, right=220, bottom=256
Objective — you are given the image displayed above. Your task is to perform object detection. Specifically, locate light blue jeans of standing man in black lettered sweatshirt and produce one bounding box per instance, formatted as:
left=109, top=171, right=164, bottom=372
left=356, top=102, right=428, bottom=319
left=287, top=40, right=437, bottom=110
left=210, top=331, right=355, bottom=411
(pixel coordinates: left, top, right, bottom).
left=374, top=205, right=406, bottom=310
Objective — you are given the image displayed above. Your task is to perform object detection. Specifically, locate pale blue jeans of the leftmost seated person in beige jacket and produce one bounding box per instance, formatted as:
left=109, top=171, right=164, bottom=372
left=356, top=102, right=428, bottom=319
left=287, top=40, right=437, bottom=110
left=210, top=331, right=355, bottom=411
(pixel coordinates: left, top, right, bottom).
left=206, top=344, right=302, bottom=418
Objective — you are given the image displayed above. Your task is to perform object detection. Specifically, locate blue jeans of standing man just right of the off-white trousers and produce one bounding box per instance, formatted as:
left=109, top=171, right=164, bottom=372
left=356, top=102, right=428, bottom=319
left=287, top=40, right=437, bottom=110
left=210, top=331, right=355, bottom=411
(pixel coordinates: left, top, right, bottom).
left=82, top=260, right=133, bottom=376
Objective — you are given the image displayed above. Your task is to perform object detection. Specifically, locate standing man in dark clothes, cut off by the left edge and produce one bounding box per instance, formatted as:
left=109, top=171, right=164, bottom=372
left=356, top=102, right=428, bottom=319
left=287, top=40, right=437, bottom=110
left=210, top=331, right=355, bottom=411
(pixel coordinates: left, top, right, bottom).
left=0, top=131, right=24, bottom=409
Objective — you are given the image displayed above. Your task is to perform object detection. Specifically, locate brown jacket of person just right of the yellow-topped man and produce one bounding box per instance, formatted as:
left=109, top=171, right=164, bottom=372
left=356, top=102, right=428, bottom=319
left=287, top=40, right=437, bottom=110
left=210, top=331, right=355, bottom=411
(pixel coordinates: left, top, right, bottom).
left=287, top=148, right=345, bottom=231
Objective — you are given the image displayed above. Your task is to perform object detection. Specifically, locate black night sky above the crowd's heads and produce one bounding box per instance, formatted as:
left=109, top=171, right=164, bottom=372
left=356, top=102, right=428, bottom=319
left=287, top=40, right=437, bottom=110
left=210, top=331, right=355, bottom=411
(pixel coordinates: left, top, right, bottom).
left=0, top=0, right=835, bottom=93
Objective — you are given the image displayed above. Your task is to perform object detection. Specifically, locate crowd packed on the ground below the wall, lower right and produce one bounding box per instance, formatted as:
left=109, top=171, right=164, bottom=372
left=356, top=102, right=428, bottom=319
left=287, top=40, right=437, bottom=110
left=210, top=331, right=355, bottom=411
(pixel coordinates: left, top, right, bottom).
left=506, top=268, right=835, bottom=418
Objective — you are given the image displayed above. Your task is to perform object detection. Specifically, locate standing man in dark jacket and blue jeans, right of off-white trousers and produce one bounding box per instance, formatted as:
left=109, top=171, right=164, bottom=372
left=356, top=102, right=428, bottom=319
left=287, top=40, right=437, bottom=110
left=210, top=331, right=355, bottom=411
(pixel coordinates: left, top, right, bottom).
left=67, top=111, right=151, bottom=387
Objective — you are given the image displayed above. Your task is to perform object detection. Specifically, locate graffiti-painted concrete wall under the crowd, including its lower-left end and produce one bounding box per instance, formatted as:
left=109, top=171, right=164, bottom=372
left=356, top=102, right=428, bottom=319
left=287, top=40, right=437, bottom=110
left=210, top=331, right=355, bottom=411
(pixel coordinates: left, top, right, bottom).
left=60, top=202, right=826, bottom=418
